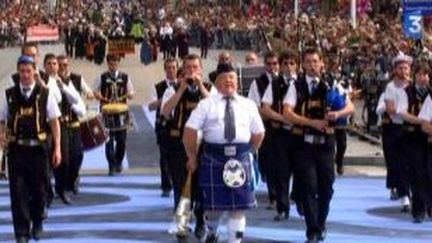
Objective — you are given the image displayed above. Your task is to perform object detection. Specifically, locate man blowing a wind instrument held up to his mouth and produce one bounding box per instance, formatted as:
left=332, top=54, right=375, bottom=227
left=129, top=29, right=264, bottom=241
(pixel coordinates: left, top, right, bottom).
left=162, top=54, right=211, bottom=238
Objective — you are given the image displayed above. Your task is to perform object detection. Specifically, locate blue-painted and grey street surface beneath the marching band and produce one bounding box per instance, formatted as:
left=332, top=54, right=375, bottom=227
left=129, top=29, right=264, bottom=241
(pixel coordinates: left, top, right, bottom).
left=0, top=45, right=424, bottom=243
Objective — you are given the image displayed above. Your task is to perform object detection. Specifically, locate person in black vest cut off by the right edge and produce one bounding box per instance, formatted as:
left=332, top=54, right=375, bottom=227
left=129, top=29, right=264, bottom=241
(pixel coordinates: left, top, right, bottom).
left=404, top=63, right=432, bottom=223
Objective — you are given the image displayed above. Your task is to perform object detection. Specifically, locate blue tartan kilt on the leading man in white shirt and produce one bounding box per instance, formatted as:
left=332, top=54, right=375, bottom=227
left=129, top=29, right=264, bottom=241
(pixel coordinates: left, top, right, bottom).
left=199, top=143, right=256, bottom=210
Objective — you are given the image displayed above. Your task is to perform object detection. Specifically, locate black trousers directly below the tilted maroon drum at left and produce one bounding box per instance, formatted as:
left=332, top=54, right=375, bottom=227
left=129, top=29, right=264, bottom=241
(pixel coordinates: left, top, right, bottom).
left=66, top=128, right=84, bottom=190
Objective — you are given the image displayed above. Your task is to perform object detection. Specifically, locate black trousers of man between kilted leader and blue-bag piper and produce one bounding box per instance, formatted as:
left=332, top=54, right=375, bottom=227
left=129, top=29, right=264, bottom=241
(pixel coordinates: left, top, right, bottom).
left=268, top=128, right=293, bottom=213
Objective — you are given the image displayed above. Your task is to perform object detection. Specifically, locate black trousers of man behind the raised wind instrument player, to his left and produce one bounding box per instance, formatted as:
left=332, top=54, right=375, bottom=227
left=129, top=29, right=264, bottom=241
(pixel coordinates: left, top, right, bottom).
left=156, top=133, right=173, bottom=191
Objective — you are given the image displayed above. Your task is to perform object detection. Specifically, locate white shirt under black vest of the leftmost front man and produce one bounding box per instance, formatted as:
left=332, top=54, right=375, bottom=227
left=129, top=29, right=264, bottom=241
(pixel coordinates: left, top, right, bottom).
left=0, top=84, right=61, bottom=122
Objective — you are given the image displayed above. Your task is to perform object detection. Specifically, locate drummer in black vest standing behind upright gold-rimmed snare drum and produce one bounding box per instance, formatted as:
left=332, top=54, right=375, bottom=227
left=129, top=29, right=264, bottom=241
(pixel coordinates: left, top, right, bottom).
left=94, top=54, right=134, bottom=176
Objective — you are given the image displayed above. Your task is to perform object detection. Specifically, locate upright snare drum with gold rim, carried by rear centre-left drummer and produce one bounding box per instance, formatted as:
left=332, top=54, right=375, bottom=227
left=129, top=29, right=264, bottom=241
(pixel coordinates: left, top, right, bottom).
left=102, top=103, right=130, bottom=131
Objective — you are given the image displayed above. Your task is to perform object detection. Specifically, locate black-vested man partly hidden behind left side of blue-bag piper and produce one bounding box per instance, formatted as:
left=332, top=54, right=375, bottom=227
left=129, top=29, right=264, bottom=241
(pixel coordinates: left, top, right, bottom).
left=262, top=52, right=301, bottom=221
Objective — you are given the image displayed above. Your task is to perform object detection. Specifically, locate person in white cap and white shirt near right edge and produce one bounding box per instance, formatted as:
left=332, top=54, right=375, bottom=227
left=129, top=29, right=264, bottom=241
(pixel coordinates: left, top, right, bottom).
left=384, top=53, right=412, bottom=212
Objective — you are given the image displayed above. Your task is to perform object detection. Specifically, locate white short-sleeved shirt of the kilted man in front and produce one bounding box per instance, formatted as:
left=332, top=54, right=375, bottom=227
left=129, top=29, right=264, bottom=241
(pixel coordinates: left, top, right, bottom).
left=186, top=93, right=265, bottom=144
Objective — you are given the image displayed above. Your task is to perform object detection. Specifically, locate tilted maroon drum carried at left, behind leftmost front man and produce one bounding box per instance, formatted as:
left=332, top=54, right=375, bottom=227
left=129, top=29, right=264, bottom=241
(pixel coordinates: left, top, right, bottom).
left=80, top=114, right=108, bottom=151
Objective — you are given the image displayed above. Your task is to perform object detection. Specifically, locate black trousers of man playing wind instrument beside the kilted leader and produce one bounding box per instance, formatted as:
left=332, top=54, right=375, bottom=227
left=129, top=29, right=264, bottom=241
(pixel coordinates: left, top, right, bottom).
left=166, top=138, right=204, bottom=220
